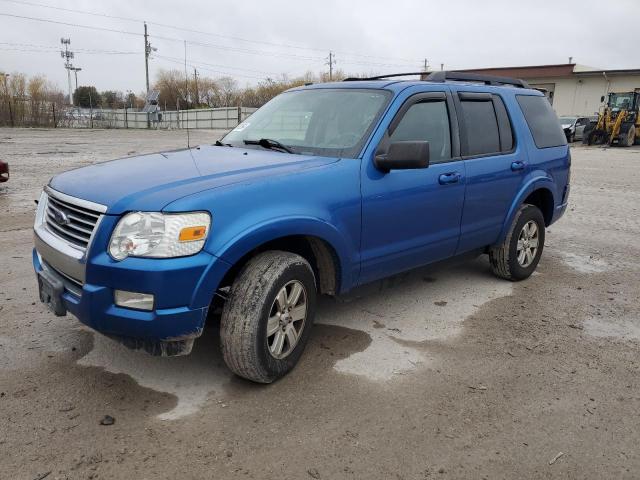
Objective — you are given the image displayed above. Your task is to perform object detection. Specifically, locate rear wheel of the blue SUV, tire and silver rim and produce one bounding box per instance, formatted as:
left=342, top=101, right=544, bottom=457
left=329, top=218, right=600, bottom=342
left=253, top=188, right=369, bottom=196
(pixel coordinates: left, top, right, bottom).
left=489, top=204, right=545, bottom=281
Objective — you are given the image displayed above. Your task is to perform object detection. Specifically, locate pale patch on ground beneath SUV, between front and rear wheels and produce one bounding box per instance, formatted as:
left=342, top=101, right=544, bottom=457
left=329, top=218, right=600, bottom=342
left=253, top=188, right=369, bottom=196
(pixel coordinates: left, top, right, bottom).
left=316, top=259, right=513, bottom=381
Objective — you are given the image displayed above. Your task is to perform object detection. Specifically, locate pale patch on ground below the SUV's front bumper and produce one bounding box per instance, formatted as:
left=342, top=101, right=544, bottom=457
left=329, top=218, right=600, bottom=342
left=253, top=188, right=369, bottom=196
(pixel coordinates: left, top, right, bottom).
left=78, top=328, right=232, bottom=420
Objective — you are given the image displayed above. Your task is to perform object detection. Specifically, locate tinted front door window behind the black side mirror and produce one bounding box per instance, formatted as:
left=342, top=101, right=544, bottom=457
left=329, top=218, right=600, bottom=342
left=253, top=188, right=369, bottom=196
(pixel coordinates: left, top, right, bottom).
left=390, top=101, right=451, bottom=162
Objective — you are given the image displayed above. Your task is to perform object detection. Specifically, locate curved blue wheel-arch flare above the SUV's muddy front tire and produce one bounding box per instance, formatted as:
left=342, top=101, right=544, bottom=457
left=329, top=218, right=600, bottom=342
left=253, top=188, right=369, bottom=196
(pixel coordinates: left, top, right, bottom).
left=214, top=216, right=359, bottom=291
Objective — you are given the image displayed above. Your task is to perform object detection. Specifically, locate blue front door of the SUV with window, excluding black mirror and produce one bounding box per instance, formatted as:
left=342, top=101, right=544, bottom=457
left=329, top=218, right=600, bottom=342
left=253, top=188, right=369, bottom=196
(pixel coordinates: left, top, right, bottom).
left=360, top=87, right=465, bottom=283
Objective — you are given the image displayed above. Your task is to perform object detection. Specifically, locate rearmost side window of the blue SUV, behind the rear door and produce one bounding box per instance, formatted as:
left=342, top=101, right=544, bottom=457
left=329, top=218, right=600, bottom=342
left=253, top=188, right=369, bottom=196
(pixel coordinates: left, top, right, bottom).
left=516, top=95, right=567, bottom=148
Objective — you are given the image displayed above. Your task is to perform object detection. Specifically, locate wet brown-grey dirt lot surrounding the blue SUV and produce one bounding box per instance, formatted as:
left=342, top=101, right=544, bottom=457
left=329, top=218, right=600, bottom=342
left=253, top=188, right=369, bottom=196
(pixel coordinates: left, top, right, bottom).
left=0, top=129, right=640, bottom=480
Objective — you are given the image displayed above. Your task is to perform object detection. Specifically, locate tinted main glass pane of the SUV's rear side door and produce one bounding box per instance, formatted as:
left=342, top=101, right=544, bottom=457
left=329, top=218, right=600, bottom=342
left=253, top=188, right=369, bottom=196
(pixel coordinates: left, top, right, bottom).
left=460, top=100, right=500, bottom=156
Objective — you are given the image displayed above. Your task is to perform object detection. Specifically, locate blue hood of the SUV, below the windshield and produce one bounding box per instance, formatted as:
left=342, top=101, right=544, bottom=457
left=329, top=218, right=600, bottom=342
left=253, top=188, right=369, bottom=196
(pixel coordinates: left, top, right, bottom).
left=49, top=145, right=337, bottom=214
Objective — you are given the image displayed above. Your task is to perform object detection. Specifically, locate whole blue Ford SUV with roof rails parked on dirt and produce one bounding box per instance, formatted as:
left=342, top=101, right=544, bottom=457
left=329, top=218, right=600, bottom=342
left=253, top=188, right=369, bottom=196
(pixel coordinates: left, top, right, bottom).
left=33, top=72, right=571, bottom=383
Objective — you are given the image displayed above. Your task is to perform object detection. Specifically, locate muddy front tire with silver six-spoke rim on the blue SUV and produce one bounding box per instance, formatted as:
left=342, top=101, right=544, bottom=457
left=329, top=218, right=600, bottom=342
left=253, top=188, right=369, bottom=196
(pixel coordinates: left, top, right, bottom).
left=220, top=251, right=316, bottom=383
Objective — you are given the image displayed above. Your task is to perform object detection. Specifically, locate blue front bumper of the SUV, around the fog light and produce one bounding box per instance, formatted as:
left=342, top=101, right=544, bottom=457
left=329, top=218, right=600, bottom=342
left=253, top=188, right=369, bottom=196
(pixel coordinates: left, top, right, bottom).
left=33, top=215, right=230, bottom=355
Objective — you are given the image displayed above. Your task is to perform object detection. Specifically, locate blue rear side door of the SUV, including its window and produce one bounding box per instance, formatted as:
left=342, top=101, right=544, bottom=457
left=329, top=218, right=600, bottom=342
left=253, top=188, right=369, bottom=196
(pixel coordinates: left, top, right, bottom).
left=452, top=86, right=527, bottom=253
